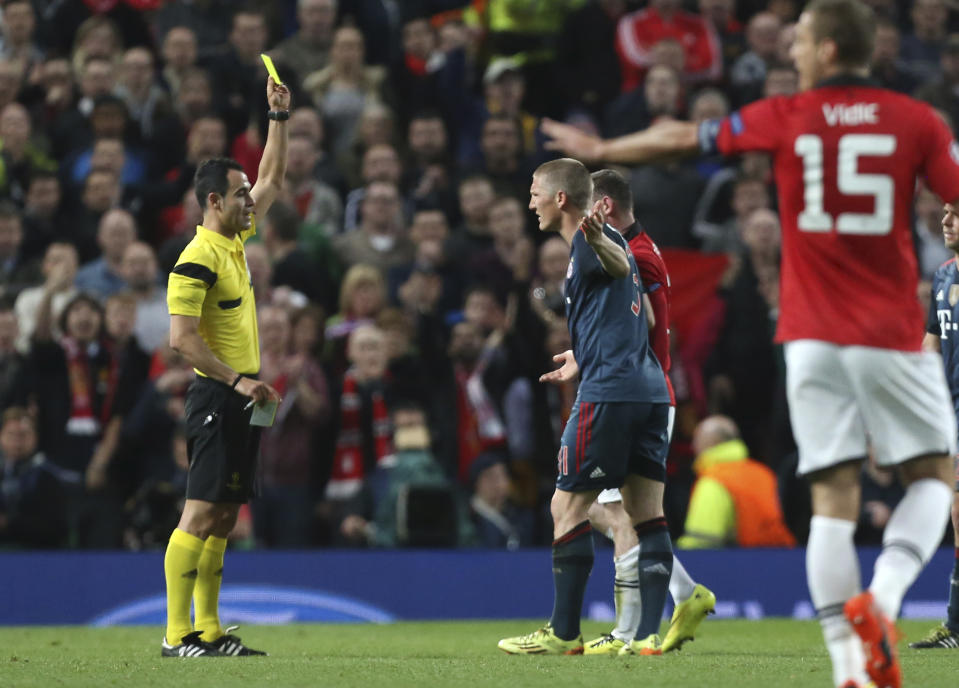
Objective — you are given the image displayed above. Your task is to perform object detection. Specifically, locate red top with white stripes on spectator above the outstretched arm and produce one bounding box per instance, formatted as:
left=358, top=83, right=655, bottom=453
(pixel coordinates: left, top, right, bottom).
left=616, top=7, right=723, bottom=92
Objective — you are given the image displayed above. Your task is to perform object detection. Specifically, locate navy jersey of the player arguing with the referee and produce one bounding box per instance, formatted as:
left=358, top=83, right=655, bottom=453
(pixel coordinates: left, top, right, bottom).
left=566, top=225, right=669, bottom=403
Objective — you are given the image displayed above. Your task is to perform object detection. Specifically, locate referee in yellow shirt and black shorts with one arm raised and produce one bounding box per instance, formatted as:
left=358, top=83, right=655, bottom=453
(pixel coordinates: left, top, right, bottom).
left=161, top=77, right=290, bottom=657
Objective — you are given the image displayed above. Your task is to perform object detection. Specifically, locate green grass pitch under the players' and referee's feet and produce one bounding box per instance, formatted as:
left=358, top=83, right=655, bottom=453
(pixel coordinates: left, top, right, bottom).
left=0, top=619, right=959, bottom=688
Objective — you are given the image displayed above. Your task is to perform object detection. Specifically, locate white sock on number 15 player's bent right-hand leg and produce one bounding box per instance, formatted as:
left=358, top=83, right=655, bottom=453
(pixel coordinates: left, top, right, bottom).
left=869, top=478, right=953, bottom=620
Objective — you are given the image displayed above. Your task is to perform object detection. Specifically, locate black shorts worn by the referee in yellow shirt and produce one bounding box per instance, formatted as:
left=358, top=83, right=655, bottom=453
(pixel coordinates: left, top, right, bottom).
left=186, top=376, right=260, bottom=504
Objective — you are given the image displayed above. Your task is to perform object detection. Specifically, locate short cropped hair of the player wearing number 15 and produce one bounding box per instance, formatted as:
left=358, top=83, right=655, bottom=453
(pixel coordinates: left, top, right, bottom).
left=806, top=0, right=876, bottom=67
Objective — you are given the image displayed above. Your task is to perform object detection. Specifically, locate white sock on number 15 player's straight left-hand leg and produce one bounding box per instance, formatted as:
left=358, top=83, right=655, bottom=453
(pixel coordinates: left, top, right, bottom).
left=806, top=516, right=868, bottom=686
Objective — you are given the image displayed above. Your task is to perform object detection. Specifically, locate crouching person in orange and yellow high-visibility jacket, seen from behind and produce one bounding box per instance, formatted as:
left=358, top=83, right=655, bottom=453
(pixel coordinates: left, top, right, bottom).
left=676, top=416, right=796, bottom=549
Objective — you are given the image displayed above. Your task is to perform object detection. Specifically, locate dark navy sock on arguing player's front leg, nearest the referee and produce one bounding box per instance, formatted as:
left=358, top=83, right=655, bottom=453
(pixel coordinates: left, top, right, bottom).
left=549, top=521, right=593, bottom=640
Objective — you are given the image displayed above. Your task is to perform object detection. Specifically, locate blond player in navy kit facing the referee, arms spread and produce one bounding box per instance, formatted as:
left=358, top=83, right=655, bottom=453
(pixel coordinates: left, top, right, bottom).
left=499, top=158, right=673, bottom=655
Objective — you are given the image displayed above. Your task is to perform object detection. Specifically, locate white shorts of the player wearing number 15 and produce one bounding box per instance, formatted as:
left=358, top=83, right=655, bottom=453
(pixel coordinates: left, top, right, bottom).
left=785, top=339, right=956, bottom=475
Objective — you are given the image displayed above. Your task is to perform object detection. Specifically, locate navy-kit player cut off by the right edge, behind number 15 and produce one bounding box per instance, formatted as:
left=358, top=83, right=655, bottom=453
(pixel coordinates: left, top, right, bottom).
left=909, top=203, right=959, bottom=650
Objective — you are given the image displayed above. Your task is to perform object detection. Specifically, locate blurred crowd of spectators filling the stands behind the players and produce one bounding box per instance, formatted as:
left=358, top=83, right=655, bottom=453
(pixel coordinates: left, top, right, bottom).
left=0, top=0, right=944, bottom=549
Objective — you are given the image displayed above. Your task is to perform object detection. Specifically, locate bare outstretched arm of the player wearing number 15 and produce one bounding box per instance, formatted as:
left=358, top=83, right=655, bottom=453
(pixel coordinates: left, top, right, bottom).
left=540, top=119, right=699, bottom=164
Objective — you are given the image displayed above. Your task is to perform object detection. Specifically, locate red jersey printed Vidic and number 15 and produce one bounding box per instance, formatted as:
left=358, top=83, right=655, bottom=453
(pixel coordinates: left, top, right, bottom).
left=699, top=75, right=959, bottom=351
